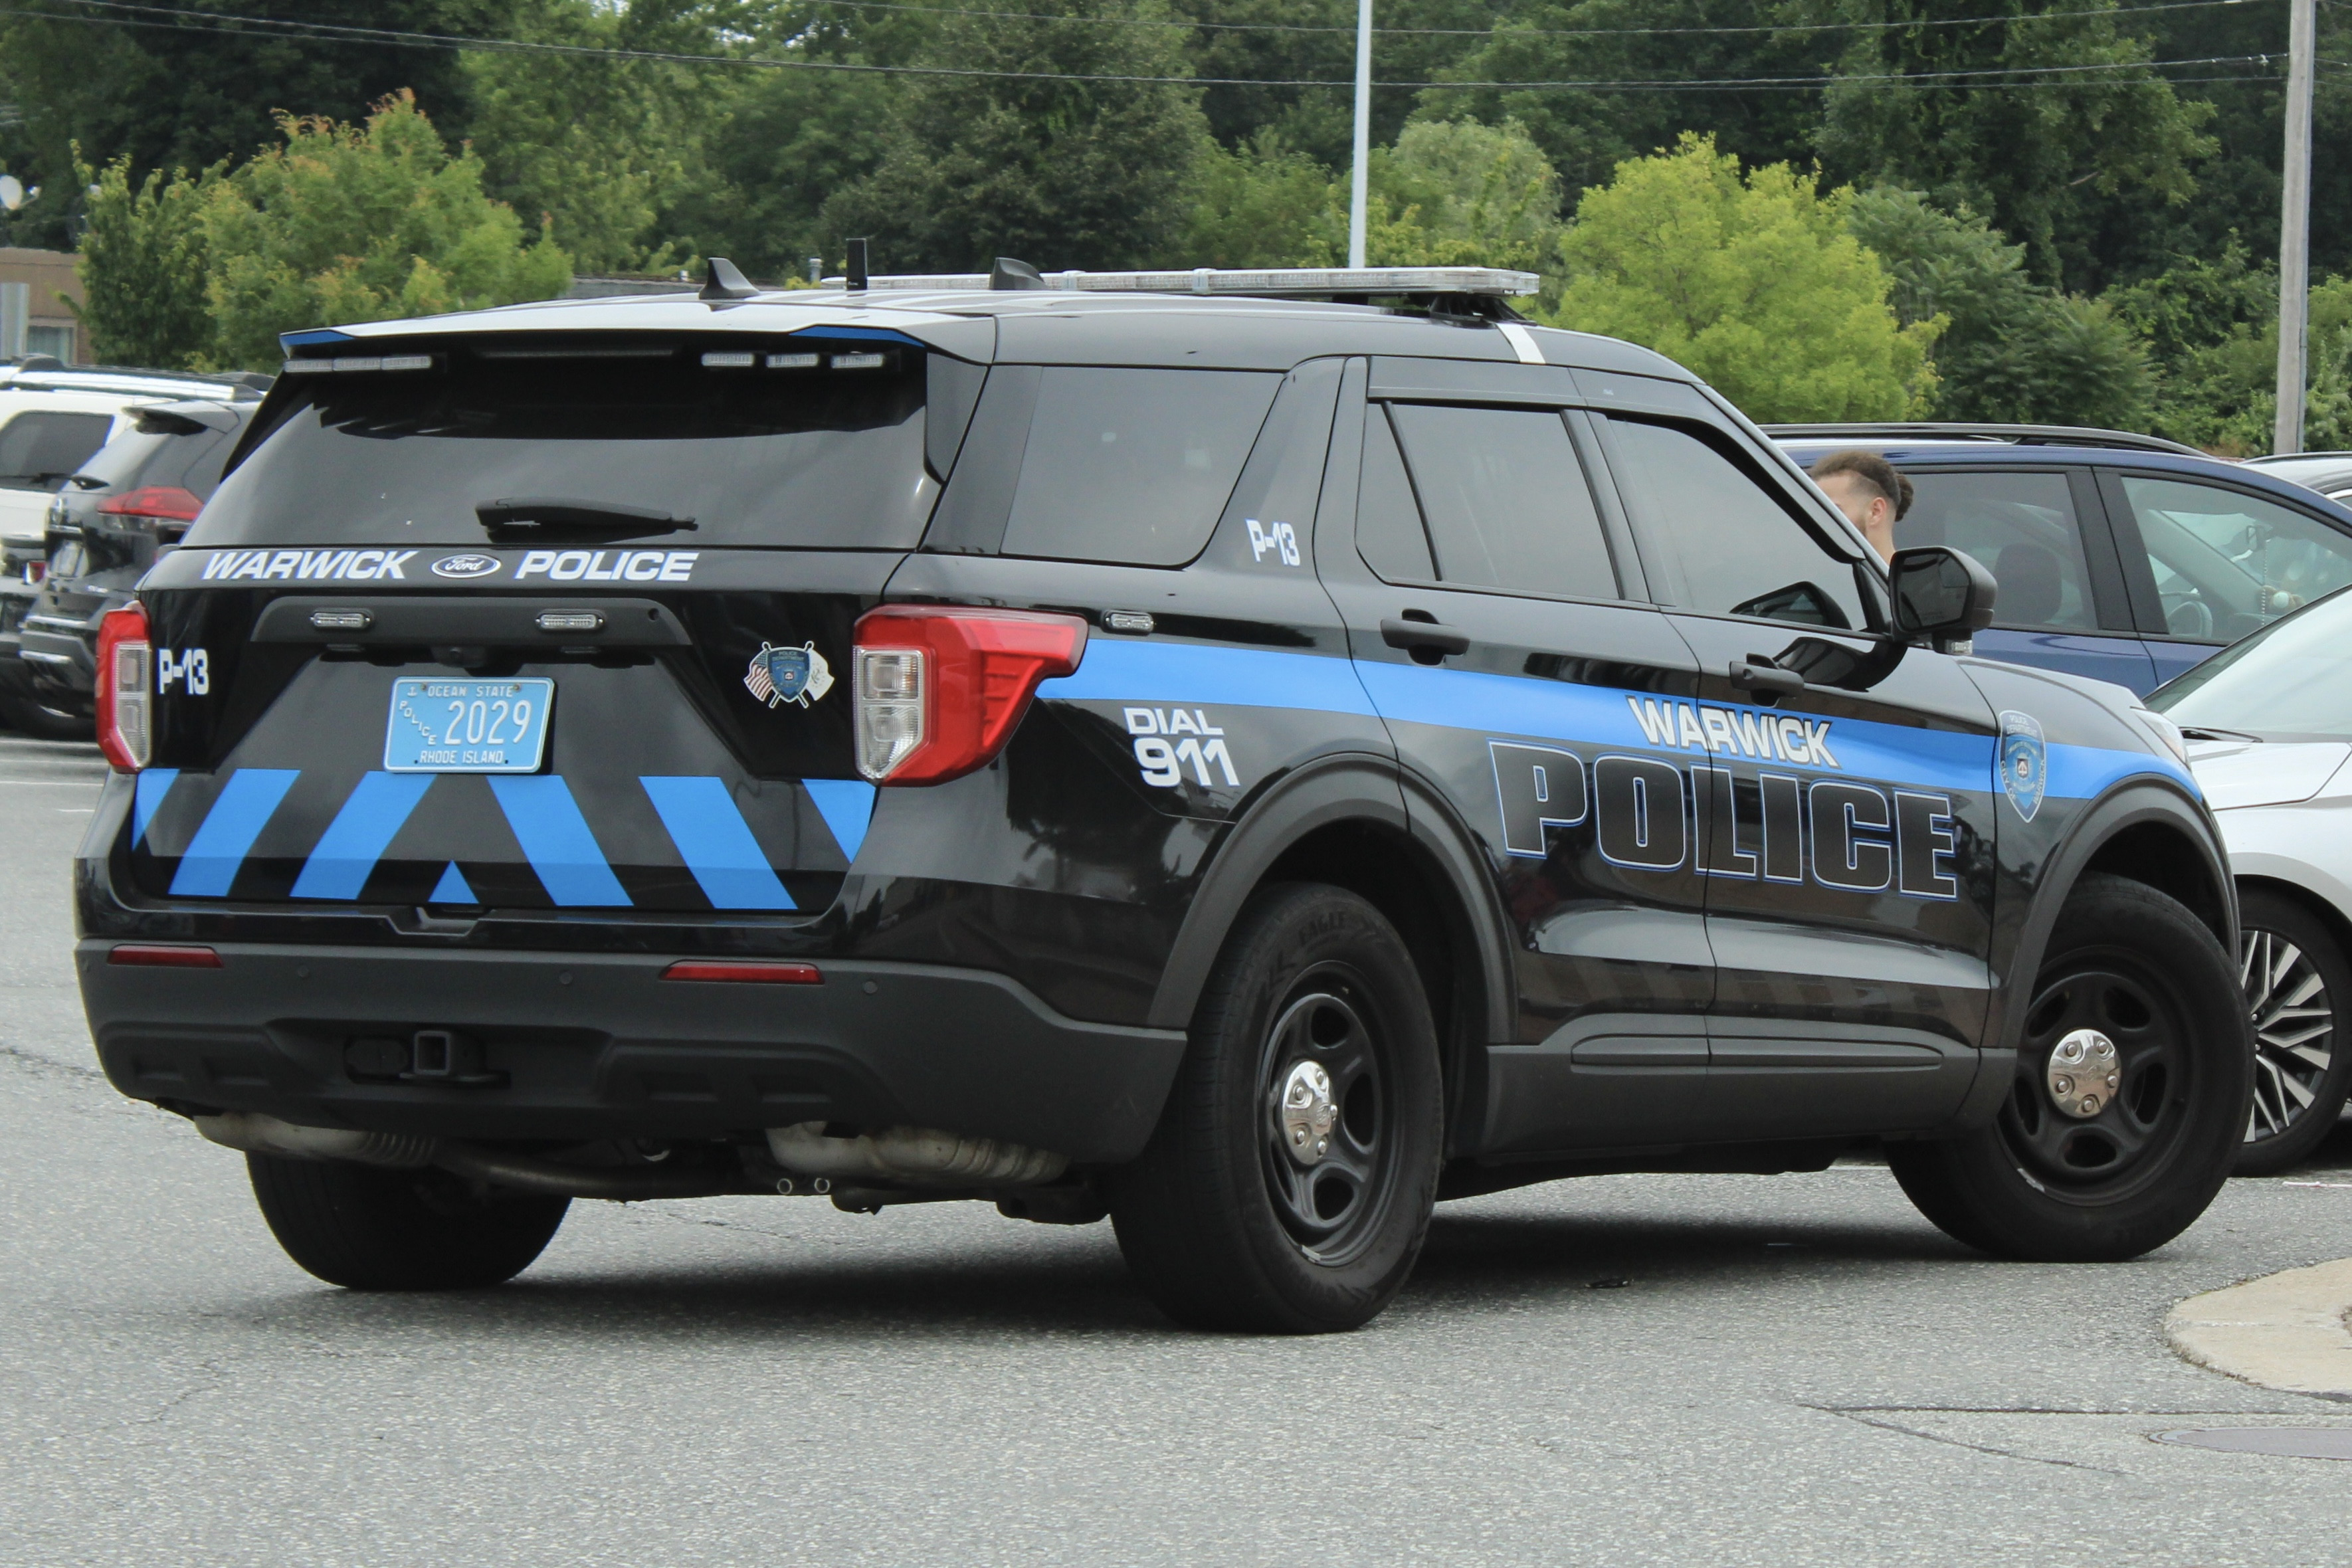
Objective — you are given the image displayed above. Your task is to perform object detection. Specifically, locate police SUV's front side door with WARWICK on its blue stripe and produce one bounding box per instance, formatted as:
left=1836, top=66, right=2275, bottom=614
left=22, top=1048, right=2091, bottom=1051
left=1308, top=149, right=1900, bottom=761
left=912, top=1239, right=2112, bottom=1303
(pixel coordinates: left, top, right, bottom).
left=1604, top=395, right=1995, bottom=1138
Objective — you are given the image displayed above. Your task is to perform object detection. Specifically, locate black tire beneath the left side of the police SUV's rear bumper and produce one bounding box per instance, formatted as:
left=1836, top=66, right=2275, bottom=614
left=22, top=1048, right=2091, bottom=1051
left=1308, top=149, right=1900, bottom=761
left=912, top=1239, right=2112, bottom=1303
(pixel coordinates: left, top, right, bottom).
left=245, top=1154, right=571, bottom=1290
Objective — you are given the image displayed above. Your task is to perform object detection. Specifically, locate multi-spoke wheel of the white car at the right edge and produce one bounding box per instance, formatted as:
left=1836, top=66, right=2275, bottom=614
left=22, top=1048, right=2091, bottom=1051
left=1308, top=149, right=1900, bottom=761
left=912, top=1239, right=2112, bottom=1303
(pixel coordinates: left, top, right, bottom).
left=2237, top=891, right=2352, bottom=1175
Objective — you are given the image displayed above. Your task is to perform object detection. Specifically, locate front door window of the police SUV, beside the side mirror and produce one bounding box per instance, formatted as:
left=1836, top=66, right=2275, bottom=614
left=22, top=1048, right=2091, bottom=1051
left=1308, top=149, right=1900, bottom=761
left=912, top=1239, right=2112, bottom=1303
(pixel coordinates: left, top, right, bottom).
left=1609, top=419, right=1865, bottom=628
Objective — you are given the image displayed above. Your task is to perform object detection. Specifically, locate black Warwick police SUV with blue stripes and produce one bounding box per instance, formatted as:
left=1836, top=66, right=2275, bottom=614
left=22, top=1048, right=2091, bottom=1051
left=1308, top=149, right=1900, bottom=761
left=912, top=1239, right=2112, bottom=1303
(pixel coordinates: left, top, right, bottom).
left=78, top=263, right=2251, bottom=1331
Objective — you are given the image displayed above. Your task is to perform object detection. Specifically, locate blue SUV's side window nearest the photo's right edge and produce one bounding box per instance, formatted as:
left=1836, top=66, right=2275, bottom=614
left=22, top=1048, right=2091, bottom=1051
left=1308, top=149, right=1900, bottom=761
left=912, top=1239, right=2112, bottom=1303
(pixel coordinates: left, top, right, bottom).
left=2124, top=475, right=2352, bottom=642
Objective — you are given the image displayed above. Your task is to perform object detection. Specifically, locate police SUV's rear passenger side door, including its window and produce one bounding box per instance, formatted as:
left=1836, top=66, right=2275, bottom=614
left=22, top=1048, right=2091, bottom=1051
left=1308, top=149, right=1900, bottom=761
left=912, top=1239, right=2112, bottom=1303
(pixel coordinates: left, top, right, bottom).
left=1317, top=359, right=1715, bottom=1152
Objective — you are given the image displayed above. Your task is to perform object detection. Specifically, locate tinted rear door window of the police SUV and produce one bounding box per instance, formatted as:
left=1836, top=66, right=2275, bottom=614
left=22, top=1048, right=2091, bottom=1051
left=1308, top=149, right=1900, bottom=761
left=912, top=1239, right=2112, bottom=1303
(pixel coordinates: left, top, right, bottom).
left=1390, top=402, right=1618, bottom=599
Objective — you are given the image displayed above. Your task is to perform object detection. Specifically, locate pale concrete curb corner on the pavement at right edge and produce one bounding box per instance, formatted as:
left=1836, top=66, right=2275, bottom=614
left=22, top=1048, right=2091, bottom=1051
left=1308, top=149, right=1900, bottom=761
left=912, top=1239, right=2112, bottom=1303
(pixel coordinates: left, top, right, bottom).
left=2164, top=1258, right=2352, bottom=1401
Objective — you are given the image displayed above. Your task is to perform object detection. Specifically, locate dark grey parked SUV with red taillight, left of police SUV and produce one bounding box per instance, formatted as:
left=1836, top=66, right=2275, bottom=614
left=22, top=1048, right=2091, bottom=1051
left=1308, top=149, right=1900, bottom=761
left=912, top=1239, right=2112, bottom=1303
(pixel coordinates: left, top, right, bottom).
left=12, top=399, right=261, bottom=735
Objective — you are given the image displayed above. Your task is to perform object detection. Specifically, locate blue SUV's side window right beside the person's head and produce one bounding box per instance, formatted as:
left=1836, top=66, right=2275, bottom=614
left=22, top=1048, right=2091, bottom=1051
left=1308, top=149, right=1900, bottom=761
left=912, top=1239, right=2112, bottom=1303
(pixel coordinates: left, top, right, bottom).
left=1896, top=472, right=2098, bottom=633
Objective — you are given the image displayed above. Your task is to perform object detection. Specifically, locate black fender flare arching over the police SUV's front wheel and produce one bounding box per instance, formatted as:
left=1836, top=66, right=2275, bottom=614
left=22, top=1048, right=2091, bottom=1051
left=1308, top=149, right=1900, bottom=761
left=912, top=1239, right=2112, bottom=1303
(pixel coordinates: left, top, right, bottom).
left=1952, top=776, right=2237, bottom=1131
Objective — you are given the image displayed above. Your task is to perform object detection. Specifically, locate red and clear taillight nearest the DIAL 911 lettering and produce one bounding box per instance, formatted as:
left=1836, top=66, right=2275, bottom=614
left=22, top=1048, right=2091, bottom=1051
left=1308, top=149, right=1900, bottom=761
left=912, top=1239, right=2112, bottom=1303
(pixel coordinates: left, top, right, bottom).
left=849, top=604, right=1086, bottom=785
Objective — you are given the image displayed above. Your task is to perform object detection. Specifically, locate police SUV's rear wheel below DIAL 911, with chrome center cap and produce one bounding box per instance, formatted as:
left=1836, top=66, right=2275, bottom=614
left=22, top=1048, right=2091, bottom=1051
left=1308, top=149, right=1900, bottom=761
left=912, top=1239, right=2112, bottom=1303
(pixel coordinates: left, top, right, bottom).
left=1108, top=884, right=1444, bottom=1333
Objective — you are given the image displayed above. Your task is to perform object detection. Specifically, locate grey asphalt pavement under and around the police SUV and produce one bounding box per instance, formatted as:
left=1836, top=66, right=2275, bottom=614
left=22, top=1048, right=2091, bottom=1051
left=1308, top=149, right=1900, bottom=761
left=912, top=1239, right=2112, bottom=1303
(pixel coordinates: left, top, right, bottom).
left=0, top=735, right=2352, bottom=1568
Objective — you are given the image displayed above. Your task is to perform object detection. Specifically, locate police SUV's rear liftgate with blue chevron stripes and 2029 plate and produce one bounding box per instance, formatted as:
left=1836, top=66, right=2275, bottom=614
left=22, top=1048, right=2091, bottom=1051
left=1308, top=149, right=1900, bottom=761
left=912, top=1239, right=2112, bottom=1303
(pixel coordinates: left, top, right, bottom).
left=125, top=334, right=981, bottom=919
